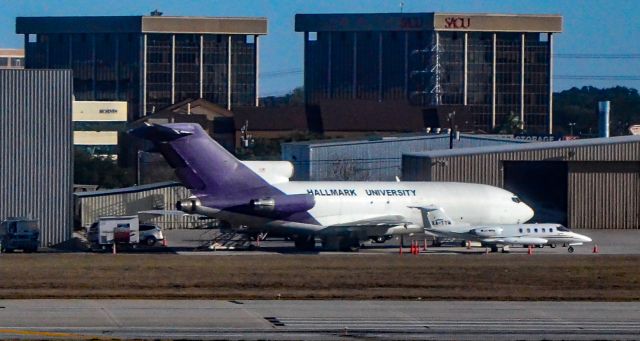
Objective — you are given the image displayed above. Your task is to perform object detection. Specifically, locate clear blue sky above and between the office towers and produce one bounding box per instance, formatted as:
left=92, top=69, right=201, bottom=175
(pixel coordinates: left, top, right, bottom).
left=0, top=0, right=640, bottom=95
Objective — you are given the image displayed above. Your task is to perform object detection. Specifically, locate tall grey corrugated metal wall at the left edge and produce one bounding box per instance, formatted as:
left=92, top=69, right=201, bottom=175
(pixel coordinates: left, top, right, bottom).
left=0, top=70, right=73, bottom=246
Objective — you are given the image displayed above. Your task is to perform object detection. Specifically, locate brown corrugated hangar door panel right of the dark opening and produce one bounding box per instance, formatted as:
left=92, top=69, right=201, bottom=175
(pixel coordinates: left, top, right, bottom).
left=569, top=161, right=640, bottom=229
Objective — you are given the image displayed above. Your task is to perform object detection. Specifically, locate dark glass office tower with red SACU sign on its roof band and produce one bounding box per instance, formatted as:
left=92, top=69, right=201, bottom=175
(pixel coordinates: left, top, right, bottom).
left=295, top=13, right=562, bottom=133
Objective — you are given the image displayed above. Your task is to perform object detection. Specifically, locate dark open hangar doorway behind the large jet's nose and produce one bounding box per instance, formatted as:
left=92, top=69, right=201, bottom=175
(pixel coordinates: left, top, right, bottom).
left=503, top=161, right=567, bottom=225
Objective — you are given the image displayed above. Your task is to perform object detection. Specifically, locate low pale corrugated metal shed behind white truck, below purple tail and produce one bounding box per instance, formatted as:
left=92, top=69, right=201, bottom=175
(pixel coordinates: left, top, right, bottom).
left=76, top=185, right=206, bottom=229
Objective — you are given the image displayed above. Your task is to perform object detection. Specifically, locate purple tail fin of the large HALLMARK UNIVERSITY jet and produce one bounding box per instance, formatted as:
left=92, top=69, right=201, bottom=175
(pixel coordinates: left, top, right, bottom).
left=130, top=123, right=282, bottom=200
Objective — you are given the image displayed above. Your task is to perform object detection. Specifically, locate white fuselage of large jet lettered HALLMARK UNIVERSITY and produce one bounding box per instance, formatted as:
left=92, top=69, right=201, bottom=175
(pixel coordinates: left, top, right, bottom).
left=210, top=181, right=533, bottom=234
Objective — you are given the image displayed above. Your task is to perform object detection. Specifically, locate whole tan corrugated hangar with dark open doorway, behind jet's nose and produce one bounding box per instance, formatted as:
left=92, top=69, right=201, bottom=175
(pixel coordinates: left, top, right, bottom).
left=402, top=136, right=640, bottom=229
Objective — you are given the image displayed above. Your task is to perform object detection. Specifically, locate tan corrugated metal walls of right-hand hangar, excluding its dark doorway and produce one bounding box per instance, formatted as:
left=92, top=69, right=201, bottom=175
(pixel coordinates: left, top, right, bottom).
left=403, top=139, right=640, bottom=229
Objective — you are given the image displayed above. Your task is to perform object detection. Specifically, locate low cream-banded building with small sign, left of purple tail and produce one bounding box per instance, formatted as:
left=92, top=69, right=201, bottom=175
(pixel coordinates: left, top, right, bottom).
left=72, top=101, right=127, bottom=159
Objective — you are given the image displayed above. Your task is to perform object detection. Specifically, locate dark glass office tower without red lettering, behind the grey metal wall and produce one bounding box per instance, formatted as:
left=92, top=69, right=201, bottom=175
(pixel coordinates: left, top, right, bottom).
left=16, top=12, right=267, bottom=120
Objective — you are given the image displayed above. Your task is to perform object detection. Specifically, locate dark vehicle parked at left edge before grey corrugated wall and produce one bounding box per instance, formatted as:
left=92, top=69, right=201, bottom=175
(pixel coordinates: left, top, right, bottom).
left=0, top=217, right=40, bottom=253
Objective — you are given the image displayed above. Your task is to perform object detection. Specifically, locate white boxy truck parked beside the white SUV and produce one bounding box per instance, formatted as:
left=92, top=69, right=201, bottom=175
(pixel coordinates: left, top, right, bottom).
left=98, top=216, right=140, bottom=247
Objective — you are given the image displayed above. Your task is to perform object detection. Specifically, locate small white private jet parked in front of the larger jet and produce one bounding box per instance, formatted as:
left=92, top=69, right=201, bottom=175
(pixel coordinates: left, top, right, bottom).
left=420, top=206, right=591, bottom=253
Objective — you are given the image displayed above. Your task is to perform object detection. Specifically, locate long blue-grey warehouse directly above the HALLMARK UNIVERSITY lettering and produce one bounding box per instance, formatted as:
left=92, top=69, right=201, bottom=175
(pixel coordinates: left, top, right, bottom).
left=282, top=134, right=526, bottom=181
